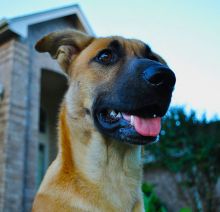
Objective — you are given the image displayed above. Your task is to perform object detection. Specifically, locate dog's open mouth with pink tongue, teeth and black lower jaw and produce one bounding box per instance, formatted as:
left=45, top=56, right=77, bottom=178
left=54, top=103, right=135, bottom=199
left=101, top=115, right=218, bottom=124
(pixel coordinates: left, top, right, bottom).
left=95, top=106, right=163, bottom=145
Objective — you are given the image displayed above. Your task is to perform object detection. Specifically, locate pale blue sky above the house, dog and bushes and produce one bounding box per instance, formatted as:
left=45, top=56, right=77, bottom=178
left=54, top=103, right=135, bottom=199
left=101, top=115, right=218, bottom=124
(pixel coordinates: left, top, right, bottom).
left=0, top=0, right=220, bottom=118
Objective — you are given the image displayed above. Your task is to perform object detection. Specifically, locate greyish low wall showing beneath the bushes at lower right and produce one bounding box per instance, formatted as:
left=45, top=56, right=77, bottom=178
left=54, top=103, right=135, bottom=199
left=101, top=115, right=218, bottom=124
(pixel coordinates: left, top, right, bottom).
left=144, top=164, right=220, bottom=212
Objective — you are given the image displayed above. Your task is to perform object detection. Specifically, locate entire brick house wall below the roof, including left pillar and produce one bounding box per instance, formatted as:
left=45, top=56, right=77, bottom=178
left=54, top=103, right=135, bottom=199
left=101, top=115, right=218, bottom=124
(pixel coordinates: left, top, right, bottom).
left=0, top=16, right=88, bottom=212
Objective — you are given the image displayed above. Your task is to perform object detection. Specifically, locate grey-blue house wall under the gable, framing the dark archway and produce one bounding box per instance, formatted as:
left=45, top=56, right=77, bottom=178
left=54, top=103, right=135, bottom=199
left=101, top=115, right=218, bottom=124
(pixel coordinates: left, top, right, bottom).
left=24, top=17, right=77, bottom=211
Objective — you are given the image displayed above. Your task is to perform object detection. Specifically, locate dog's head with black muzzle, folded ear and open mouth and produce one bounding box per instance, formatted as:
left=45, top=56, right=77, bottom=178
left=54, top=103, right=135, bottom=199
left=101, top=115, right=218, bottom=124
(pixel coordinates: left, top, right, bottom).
left=36, top=30, right=176, bottom=144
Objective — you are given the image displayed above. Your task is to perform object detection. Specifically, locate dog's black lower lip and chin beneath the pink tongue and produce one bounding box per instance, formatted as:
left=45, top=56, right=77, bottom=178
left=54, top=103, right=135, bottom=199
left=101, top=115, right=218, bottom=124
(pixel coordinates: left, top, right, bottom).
left=94, top=110, right=162, bottom=145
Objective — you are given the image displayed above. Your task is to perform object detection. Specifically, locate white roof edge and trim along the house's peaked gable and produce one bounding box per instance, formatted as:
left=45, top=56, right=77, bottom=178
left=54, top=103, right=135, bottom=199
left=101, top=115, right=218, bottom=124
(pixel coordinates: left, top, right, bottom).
left=0, top=4, right=94, bottom=40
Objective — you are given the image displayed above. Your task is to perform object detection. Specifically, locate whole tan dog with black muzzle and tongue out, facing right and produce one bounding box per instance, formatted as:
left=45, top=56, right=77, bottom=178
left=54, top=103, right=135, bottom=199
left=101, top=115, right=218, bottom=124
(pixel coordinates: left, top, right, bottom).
left=33, top=30, right=176, bottom=212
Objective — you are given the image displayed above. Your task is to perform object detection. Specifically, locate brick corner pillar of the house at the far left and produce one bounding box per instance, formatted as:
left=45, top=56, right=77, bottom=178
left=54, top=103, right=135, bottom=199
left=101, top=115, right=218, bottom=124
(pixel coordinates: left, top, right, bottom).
left=0, top=40, right=28, bottom=212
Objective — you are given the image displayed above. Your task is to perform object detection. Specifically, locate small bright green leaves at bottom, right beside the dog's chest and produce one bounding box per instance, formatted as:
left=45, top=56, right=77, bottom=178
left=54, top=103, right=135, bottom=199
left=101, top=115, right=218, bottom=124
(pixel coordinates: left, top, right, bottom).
left=142, top=183, right=167, bottom=212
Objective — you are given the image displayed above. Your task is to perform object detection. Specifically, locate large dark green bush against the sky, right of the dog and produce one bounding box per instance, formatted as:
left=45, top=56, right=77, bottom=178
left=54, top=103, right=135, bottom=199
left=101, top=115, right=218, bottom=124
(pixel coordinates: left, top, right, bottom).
left=146, top=107, right=220, bottom=211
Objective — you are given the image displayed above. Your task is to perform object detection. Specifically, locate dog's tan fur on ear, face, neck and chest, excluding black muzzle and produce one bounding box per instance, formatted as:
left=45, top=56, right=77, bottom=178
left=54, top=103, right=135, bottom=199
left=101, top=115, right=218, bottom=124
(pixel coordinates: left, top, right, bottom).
left=33, top=31, right=165, bottom=212
